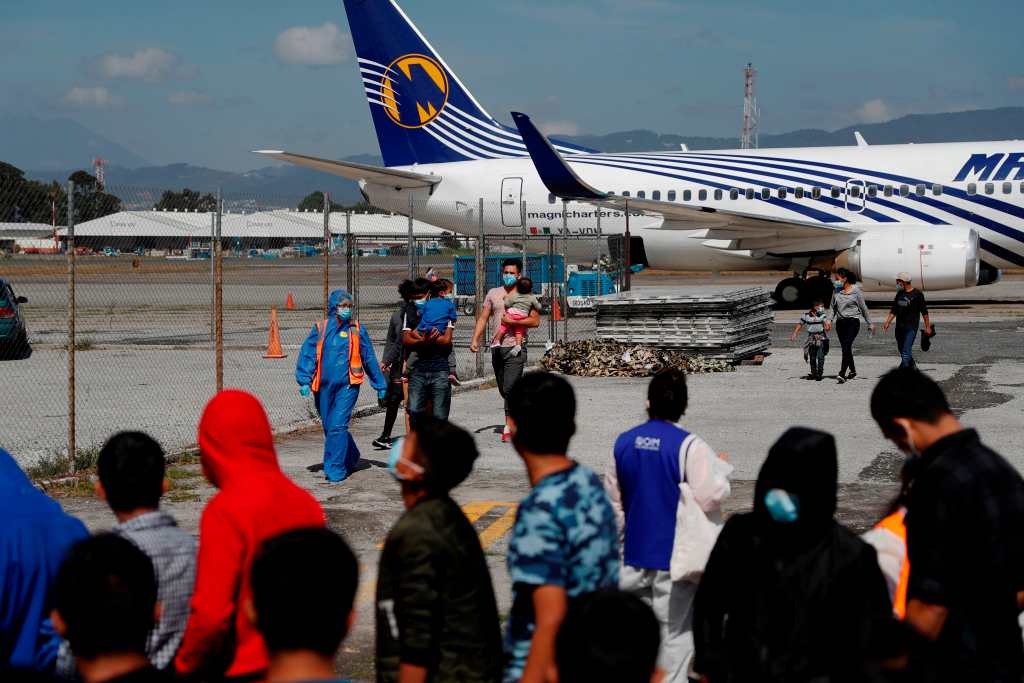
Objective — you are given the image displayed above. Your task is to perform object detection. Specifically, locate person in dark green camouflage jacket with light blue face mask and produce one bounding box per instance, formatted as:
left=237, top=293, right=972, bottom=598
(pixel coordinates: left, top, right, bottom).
left=377, top=416, right=502, bottom=683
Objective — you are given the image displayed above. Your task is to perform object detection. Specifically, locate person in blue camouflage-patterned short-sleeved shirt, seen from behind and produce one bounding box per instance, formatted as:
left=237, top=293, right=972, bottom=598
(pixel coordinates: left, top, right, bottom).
left=504, top=373, right=620, bottom=683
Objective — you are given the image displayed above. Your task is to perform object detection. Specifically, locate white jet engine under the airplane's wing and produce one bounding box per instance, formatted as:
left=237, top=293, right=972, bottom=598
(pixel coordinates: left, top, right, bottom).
left=839, top=226, right=982, bottom=291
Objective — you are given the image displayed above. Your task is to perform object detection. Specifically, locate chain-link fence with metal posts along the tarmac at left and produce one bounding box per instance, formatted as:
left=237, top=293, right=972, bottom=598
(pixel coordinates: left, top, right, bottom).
left=0, top=184, right=622, bottom=474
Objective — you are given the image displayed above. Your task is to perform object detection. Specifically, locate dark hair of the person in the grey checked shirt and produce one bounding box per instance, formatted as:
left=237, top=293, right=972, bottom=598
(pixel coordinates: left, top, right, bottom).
left=96, top=432, right=166, bottom=512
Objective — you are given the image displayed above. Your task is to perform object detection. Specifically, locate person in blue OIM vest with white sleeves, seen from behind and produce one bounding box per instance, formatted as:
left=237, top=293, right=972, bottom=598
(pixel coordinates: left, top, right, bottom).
left=605, top=369, right=732, bottom=683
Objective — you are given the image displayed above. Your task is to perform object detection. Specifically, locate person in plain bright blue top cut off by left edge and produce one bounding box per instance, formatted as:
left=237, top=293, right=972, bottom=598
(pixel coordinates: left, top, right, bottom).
left=0, top=449, right=89, bottom=681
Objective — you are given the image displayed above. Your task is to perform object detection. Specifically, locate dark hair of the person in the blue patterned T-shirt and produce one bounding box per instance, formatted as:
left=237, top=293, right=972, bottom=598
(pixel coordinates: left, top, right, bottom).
left=509, top=373, right=575, bottom=455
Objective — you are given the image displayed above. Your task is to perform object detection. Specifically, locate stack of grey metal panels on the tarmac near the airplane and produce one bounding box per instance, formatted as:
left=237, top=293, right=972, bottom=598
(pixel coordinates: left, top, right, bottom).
left=597, top=287, right=775, bottom=362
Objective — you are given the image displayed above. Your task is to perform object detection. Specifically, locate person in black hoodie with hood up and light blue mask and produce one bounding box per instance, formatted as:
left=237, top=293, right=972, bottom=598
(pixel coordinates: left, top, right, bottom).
left=693, top=427, right=896, bottom=683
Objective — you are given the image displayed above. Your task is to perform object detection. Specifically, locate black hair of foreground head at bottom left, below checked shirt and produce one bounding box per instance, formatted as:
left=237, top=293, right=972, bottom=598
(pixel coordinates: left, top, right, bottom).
left=53, top=533, right=157, bottom=659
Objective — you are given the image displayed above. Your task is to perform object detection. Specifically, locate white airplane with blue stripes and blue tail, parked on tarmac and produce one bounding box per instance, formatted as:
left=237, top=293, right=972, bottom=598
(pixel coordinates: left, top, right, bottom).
left=259, top=0, right=1024, bottom=303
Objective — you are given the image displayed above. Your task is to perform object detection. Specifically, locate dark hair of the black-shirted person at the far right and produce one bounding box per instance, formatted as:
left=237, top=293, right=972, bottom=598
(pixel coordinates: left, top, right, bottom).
left=871, top=368, right=952, bottom=435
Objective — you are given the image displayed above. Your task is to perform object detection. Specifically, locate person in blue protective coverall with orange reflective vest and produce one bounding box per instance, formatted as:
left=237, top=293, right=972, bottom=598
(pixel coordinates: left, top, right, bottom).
left=295, top=290, right=387, bottom=481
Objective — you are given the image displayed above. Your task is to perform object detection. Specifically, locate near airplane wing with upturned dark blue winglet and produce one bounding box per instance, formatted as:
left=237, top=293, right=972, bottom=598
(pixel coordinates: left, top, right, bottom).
left=512, top=112, right=863, bottom=253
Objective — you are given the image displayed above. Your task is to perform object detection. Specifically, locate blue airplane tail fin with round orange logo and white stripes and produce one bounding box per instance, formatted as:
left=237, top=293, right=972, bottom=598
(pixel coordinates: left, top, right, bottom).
left=344, top=0, right=594, bottom=166
